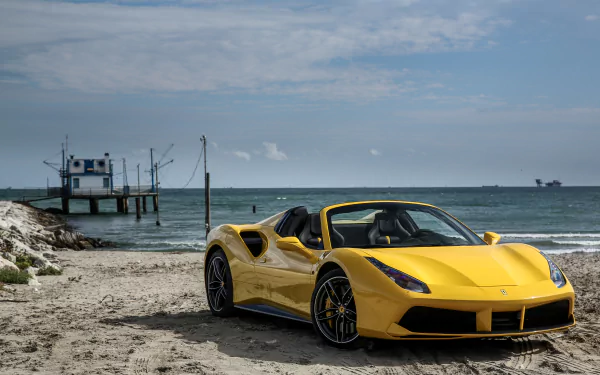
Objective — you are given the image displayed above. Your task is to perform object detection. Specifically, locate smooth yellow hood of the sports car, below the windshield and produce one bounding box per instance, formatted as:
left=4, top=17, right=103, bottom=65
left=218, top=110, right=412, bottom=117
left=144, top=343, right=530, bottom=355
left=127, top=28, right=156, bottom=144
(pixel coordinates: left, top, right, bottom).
left=364, top=244, right=550, bottom=287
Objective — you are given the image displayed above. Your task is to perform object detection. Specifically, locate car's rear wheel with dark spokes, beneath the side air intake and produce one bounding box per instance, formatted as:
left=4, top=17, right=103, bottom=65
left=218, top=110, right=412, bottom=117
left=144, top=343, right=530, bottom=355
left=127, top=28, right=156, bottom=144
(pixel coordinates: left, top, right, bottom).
left=205, top=250, right=235, bottom=316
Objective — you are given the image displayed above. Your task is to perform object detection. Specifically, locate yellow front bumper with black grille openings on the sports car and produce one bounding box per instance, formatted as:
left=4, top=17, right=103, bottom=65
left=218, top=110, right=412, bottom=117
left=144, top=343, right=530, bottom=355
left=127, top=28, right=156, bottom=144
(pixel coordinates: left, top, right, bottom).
left=355, top=282, right=575, bottom=340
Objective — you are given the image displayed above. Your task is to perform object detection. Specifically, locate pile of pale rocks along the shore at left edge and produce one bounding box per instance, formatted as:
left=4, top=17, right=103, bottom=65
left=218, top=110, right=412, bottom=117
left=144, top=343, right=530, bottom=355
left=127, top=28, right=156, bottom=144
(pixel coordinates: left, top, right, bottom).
left=0, top=201, right=114, bottom=286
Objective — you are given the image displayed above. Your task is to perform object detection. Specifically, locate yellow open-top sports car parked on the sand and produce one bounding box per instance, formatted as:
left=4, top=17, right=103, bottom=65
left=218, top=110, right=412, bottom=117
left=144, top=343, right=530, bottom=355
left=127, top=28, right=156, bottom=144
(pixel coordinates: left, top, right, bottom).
left=204, top=201, right=575, bottom=347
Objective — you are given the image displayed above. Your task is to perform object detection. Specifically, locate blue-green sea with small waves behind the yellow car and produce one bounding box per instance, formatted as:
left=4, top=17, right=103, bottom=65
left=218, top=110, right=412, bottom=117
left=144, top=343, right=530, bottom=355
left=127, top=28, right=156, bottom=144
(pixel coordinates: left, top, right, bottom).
left=0, top=187, right=600, bottom=252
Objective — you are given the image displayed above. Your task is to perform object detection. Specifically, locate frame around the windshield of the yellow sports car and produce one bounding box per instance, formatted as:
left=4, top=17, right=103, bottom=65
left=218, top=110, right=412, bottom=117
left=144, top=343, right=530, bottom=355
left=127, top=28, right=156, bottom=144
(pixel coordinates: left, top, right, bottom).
left=321, top=200, right=486, bottom=250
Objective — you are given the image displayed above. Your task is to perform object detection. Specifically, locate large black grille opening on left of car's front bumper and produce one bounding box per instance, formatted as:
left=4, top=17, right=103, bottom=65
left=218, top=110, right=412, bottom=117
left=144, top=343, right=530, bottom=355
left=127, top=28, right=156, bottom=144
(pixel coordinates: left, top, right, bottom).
left=399, top=306, right=477, bottom=333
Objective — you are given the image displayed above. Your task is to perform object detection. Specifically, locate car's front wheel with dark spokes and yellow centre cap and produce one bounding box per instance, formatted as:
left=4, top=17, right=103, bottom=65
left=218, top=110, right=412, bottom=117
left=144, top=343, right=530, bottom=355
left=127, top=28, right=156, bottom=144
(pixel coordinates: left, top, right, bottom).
left=311, top=269, right=359, bottom=349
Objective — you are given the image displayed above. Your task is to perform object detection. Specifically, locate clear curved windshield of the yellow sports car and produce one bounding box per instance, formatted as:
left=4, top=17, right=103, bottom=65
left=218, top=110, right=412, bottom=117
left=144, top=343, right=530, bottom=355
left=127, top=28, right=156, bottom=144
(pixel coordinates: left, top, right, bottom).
left=327, top=202, right=485, bottom=248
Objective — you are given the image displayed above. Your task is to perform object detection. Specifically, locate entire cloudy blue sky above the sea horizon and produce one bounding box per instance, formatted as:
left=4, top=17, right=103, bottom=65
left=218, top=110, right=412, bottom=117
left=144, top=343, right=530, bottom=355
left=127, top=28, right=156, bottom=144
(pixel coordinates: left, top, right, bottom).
left=0, top=0, right=600, bottom=187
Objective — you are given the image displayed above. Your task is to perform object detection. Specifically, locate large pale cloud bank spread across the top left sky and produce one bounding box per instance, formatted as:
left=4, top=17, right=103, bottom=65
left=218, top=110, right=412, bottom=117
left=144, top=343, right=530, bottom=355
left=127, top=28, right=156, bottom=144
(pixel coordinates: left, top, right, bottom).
left=0, top=0, right=509, bottom=100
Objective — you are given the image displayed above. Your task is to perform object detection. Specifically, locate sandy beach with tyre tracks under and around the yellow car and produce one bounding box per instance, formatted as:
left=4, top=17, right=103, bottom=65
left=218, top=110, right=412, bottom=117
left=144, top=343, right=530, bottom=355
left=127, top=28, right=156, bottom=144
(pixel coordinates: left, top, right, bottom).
left=0, top=251, right=600, bottom=374
